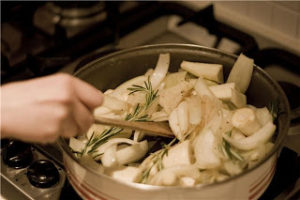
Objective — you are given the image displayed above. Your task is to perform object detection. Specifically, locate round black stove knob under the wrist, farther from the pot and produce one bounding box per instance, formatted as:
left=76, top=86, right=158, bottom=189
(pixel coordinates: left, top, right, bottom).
left=2, top=140, right=33, bottom=169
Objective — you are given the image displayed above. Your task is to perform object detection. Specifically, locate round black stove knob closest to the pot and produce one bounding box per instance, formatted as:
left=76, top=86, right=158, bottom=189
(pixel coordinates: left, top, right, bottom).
left=27, top=160, right=59, bottom=188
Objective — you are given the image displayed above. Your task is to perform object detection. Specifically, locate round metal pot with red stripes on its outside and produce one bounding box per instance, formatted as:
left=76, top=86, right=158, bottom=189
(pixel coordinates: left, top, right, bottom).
left=60, top=44, right=289, bottom=200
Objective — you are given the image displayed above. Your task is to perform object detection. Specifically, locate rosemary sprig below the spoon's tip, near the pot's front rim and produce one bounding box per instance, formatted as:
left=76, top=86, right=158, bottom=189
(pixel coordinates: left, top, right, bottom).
left=138, top=138, right=176, bottom=183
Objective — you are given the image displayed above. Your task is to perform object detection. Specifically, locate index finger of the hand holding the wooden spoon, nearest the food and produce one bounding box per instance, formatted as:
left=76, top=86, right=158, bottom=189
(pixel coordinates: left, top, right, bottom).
left=74, top=78, right=104, bottom=110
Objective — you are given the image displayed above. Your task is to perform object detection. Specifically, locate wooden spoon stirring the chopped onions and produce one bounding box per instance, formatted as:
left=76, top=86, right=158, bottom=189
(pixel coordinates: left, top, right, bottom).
left=94, top=116, right=174, bottom=138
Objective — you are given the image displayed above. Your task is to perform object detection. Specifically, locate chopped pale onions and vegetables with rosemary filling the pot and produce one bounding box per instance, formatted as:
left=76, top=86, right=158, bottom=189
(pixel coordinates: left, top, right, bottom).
left=69, top=53, right=276, bottom=186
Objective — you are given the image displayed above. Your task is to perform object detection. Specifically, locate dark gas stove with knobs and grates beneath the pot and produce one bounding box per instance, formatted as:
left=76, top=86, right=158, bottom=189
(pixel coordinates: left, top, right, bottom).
left=1, top=1, right=300, bottom=200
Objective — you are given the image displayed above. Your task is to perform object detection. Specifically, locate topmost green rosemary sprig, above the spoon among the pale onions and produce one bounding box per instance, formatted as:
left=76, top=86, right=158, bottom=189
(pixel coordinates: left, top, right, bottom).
left=127, top=76, right=158, bottom=110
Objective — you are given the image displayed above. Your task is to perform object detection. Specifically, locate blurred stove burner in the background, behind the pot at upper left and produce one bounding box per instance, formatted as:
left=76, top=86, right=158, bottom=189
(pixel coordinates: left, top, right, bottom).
left=33, top=2, right=107, bottom=38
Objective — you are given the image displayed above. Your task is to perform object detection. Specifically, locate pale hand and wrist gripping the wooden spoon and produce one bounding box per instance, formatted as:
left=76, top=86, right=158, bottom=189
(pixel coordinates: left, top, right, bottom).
left=1, top=73, right=103, bottom=143
